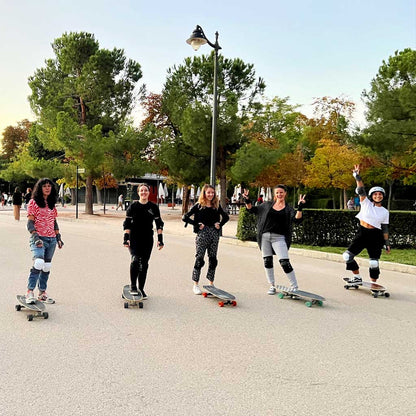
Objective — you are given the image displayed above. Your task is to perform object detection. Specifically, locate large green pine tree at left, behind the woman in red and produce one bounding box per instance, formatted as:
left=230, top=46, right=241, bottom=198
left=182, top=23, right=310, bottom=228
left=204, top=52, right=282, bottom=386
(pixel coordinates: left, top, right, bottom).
left=29, top=32, right=142, bottom=214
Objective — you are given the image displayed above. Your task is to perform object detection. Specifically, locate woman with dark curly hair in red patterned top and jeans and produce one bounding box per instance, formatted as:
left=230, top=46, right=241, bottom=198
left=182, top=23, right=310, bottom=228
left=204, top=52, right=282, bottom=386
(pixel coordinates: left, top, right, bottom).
left=26, top=178, right=64, bottom=303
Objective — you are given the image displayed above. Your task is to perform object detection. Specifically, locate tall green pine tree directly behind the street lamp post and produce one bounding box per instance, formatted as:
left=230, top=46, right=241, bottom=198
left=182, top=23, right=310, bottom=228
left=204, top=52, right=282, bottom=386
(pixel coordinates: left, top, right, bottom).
left=154, top=53, right=265, bottom=207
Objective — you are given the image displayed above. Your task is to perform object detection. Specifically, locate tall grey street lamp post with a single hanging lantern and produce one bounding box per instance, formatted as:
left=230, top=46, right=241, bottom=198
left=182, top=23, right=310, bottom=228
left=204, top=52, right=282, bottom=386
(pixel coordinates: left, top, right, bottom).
left=186, top=25, right=222, bottom=186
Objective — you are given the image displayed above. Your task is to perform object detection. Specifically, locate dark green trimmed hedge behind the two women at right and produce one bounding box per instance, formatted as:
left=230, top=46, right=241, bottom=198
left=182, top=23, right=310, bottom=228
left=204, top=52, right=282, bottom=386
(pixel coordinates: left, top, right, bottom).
left=237, top=208, right=416, bottom=248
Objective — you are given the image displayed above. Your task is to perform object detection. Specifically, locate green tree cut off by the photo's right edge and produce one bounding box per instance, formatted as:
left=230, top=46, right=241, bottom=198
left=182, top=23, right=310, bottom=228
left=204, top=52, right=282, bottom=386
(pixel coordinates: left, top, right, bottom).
left=359, top=48, right=416, bottom=205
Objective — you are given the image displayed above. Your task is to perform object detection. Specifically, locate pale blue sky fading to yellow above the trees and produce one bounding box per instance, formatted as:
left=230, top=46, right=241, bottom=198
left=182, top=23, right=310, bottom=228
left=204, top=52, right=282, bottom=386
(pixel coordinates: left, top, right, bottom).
left=0, top=0, right=416, bottom=134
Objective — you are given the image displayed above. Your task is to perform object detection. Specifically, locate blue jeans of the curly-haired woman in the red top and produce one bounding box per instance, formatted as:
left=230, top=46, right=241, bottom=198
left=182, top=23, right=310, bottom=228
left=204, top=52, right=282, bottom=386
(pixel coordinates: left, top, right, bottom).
left=27, top=237, right=56, bottom=292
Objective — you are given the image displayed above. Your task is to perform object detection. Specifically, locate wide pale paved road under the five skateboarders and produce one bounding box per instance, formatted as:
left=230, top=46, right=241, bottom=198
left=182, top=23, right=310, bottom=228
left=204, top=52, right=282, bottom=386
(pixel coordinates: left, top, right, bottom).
left=0, top=213, right=416, bottom=416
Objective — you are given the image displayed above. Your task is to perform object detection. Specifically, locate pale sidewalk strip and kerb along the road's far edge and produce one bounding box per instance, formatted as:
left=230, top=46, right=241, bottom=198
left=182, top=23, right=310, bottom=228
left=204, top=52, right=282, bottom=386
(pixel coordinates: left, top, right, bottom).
left=0, top=204, right=416, bottom=276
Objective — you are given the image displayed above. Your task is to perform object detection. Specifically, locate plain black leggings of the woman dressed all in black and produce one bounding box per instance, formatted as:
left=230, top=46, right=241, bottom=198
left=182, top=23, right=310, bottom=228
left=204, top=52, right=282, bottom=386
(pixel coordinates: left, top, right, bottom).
left=130, top=234, right=153, bottom=290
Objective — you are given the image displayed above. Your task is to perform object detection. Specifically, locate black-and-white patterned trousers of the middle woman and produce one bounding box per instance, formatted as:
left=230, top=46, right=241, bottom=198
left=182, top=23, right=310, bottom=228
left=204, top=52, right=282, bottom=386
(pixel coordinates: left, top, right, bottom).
left=192, top=226, right=220, bottom=283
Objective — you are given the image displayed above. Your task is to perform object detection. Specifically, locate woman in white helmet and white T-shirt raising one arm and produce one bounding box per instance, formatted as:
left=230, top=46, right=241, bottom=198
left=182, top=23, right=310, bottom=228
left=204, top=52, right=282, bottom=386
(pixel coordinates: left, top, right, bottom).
left=343, top=165, right=390, bottom=285
